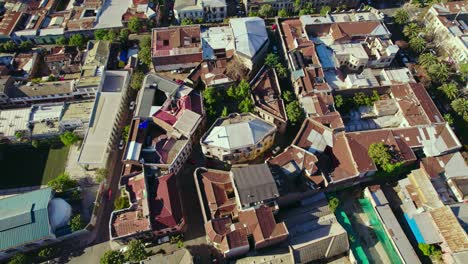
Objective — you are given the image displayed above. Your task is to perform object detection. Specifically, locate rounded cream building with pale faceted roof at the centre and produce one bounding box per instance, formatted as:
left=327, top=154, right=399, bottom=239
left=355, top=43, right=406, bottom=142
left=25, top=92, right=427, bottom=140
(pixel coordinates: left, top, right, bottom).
left=200, top=113, right=277, bottom=163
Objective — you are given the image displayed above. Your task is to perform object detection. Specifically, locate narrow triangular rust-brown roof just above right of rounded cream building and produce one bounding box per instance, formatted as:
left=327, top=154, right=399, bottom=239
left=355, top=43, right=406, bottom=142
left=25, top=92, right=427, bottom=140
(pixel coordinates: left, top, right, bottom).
left=250, top=68, right=287, bottom=121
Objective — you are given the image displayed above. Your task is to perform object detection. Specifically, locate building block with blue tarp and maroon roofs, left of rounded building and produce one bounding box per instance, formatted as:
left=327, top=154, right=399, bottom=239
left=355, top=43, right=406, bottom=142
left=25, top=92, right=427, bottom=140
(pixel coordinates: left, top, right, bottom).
left=122, top=74, right=205, bottom=174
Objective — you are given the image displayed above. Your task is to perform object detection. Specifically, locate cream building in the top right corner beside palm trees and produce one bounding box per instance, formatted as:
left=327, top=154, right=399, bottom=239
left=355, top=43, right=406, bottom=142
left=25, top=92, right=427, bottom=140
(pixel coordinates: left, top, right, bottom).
left=424, top=1, right=468, bottom=63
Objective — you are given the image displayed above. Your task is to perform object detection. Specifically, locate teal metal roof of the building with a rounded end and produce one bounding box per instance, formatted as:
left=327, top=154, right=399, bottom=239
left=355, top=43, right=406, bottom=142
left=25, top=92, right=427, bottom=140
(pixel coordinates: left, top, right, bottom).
left=0, top=188, right=54, bottom=250
